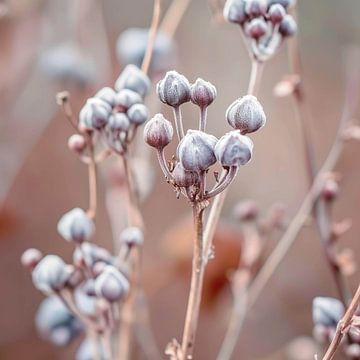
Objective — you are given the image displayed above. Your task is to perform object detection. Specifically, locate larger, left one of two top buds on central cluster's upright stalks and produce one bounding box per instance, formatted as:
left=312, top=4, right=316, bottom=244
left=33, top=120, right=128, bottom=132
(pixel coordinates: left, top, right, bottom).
left=156, top=71, right=190, bottom=107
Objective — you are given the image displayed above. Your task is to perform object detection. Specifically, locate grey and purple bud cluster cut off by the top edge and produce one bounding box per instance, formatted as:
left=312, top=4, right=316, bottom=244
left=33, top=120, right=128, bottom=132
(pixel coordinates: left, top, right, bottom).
left=223, top=0, right=297, bottom=62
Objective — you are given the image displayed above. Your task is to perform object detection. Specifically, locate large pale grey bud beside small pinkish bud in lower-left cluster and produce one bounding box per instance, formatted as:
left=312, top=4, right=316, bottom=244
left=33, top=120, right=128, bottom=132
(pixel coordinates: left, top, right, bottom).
left=32, top=255, right=68, bottom=294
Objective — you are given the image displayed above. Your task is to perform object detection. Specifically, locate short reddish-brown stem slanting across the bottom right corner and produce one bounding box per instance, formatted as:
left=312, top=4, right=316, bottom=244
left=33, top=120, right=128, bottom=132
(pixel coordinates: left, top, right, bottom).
left=323, top=286, right=360, bottom=360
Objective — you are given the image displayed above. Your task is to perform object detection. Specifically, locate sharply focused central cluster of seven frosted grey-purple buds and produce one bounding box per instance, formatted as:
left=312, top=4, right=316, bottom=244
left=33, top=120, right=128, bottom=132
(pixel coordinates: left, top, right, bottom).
left=144, top=71, right=266, bottom=203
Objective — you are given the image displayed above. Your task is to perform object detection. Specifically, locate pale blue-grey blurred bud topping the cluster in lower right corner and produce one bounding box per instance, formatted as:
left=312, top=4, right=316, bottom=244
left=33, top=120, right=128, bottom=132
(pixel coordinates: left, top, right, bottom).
left=312, top=297, right=345, bottom=327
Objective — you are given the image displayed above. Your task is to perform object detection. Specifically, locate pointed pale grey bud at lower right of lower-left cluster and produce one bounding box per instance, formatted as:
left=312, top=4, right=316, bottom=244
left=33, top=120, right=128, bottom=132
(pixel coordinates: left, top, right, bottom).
left=95, top=265, right=130, bottom=302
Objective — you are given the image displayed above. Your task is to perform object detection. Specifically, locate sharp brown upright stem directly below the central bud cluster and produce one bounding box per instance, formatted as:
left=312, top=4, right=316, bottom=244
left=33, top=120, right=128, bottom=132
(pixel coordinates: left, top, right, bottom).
left=181, top=203, right=206, bottom=360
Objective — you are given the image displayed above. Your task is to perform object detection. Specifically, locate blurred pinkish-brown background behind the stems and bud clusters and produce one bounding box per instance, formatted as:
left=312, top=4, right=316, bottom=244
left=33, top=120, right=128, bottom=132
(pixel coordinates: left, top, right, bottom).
left=0, top=0, right=360, bottom=360
